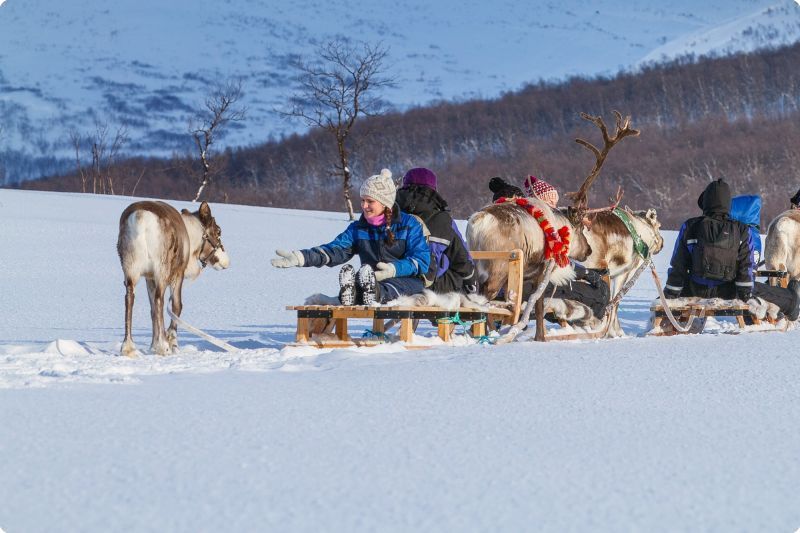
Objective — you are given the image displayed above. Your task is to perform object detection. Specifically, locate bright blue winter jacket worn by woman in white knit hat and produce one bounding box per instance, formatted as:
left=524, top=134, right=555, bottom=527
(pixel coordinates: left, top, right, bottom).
left=301, top=205, right=430, bottom=278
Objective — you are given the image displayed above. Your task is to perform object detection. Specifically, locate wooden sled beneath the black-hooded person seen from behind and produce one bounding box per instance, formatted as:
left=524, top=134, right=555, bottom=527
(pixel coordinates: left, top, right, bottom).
left=647, top=303, right=788, bottom=337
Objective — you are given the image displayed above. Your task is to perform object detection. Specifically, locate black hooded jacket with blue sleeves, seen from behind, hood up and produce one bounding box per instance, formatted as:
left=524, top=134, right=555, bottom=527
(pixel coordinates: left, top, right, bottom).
left=666, top=180, right=754, bottom=297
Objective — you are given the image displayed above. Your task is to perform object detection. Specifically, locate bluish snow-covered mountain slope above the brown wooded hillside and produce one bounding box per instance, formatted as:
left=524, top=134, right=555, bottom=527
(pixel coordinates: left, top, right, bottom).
left=0, top=0, right=800, bottom=181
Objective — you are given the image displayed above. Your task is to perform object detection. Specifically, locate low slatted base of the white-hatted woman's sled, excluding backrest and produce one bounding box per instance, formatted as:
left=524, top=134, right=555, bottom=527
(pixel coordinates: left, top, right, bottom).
left=286, top=305, right=513, bottom=349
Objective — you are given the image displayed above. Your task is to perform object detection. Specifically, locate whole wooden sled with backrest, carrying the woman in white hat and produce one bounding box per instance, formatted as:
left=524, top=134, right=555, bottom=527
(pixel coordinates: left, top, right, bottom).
left=286, top=249, right=523, bottom=349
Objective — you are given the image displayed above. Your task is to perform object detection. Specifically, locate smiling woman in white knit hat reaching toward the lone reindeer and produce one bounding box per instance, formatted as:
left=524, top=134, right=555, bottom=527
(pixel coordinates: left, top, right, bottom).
left=271, top=169, right=430, bottom=305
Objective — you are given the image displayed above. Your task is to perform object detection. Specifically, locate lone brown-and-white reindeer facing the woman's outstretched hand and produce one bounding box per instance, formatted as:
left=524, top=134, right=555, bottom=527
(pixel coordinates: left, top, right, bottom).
left=117, top=201, right=230, bottom=357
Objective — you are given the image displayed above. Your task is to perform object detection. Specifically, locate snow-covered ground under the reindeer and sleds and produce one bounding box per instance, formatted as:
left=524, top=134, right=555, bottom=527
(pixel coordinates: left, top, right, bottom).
left=0, top=189, right=800, bottom=533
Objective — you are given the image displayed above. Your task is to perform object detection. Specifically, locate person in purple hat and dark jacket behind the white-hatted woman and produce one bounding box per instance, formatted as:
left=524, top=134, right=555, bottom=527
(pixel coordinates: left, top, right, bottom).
left=397, top=167, right=478, bottom=294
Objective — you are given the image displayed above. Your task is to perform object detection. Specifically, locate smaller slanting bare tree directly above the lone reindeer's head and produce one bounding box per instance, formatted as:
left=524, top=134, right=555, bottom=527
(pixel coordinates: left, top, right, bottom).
left=189, top=80, right=246, bottom=202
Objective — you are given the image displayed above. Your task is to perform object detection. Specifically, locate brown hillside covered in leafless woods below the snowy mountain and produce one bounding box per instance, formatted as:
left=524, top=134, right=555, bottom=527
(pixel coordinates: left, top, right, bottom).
left=25, top=45, right=800, bottom=228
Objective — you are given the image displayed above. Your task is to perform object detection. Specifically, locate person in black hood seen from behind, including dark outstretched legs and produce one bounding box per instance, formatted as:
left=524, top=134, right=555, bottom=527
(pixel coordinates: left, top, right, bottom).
left=664, top=179, right=800, bottom=320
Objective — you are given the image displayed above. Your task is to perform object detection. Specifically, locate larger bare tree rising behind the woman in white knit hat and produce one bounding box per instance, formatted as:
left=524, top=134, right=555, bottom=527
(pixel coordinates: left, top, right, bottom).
left=280, top=38, right=394, bottom=220
